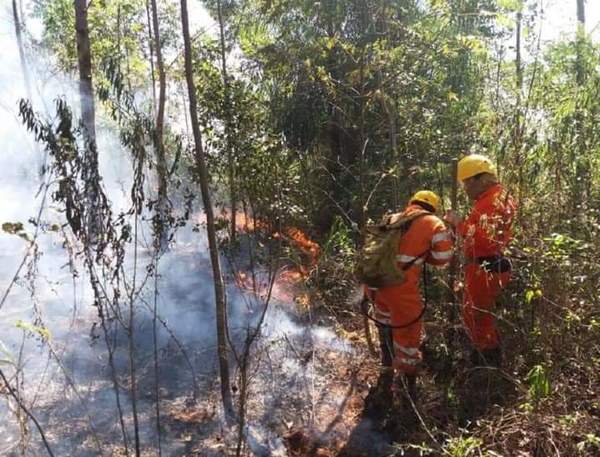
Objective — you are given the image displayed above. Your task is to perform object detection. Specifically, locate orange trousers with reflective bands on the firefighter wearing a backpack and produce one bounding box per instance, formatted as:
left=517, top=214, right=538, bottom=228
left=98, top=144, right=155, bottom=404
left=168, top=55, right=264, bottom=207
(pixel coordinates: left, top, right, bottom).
left=375, top=284, right=423, bottom=374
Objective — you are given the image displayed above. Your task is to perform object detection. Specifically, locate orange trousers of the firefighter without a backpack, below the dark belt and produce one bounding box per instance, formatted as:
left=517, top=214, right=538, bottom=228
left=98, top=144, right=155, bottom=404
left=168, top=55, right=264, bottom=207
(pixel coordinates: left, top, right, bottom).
left=463, top=263, right=510, bottom=351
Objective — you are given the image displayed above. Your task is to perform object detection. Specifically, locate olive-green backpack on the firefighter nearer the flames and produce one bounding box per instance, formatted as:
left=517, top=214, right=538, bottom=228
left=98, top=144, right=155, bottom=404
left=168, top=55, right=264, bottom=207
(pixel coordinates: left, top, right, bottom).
left=355, top=210, right=431, bottom=288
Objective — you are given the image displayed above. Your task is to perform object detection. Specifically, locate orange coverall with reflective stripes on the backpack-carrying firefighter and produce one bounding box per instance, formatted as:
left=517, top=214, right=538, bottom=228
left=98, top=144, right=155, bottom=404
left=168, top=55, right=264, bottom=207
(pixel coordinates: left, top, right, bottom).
left=369, top=205, right=453, bottom=374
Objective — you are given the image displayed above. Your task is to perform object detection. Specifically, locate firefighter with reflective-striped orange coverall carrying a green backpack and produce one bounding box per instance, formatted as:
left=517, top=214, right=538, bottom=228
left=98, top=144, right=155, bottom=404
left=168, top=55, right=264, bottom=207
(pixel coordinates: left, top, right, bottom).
left=367, top=191, right=453, bottom=401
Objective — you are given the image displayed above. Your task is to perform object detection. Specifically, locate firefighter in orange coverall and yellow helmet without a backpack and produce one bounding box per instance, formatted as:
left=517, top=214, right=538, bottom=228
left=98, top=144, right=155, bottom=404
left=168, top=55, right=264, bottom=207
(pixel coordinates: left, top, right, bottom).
left=445, top=154, right=516, bottom=367
